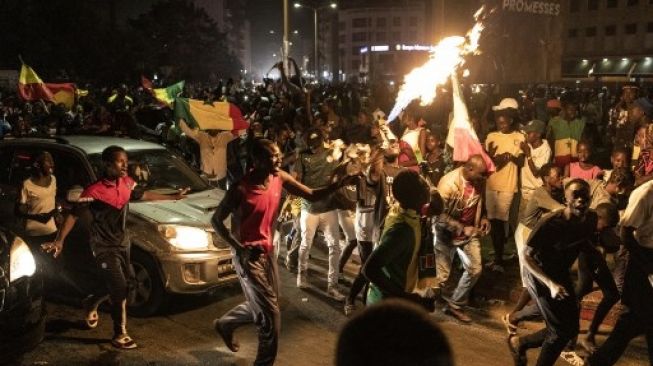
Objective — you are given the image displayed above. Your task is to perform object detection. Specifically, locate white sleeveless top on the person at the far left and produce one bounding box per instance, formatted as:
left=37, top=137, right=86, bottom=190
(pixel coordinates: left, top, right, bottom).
left=20, top=175, right=57, bottom=236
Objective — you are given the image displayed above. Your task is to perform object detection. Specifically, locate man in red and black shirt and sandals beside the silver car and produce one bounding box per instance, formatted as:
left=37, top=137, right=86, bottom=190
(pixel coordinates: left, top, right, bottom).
left=42, top=145, right=188, bottom=349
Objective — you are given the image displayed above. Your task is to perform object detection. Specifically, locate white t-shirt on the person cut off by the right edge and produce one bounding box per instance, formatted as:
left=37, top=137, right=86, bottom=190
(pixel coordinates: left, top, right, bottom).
left=621, top=181, right=653, bottom=249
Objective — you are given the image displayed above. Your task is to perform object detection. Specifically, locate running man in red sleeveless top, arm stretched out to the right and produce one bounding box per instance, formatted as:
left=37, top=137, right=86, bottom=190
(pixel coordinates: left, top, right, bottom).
left=211, top=139, right=358, bottom=365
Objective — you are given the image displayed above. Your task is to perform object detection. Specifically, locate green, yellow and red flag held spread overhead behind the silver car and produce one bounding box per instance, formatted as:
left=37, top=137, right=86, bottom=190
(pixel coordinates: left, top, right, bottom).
left=175, top=98, right=249, bottom=131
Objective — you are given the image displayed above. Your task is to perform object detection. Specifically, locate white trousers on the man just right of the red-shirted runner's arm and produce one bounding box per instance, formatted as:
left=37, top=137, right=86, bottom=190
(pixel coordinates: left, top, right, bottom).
left=297, top=209, right=340, bottom=286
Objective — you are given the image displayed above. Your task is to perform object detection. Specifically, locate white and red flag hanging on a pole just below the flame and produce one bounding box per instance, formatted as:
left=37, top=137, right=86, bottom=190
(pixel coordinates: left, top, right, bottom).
left=447, top=74, right=496, bottom=172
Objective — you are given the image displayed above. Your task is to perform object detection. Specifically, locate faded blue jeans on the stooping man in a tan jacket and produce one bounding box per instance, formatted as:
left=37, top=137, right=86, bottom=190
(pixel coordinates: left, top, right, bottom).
left=435, top=234, right=483, bottom=309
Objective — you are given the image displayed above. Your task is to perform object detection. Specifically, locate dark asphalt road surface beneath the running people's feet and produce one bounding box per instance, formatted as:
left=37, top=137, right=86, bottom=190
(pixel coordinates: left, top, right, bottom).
left=12, top=250, right=647, bottom=366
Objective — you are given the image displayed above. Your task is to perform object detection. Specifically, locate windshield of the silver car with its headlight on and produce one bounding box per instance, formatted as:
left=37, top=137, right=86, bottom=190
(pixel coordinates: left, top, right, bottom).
left=89, top=149, right=211, bottom=194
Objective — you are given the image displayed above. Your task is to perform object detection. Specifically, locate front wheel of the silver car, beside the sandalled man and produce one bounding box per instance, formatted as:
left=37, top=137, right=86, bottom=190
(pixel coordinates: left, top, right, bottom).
left=129, top=250, right=166, bottom=316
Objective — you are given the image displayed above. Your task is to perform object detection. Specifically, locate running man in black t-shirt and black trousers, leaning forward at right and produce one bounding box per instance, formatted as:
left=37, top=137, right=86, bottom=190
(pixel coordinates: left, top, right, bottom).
left=508, top=179, right=598, bottom=366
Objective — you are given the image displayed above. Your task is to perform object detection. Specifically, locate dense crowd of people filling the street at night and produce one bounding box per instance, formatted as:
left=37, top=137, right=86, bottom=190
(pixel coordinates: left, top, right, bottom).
left=6, top=60, right=653, bottom=365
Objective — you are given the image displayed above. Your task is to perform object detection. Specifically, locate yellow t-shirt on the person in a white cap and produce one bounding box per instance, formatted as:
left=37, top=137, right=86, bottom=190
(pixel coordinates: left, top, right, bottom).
left=485, top=132, right=525, bottom=192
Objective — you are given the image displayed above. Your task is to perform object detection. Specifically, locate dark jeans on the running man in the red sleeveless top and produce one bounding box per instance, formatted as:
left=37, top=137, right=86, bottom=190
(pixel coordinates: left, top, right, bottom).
left=220, top=249, right=281, bottom=365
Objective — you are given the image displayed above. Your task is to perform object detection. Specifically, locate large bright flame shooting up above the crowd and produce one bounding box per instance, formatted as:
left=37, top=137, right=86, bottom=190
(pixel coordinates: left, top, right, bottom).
left=388, top=6, right=486, bottom=122
